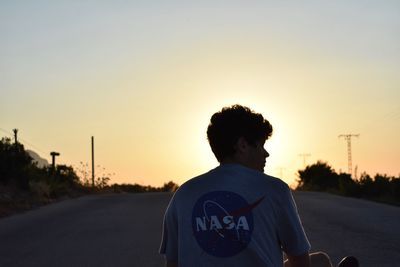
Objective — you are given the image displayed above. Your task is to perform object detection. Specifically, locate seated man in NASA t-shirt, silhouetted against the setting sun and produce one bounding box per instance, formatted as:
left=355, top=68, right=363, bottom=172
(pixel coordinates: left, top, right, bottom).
left=160, top=105, right=360, bottom=267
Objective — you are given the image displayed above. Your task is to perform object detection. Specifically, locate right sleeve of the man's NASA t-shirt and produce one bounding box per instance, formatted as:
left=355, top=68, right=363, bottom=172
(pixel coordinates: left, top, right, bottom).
left=278, top=188, right=311, bottom=256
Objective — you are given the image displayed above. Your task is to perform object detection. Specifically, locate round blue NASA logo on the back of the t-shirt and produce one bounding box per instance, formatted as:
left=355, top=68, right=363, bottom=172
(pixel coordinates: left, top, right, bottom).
left=192, top=191, right=263, bottom=257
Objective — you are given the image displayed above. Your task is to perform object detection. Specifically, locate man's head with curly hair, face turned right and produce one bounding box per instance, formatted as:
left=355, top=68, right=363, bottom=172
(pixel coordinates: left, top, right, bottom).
left=207, top=105, right=272, bottom=171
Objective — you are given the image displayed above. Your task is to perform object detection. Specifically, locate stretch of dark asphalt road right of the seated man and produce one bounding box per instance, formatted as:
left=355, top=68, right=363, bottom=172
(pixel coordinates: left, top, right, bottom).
left=295, top=192, right=400, bottom=267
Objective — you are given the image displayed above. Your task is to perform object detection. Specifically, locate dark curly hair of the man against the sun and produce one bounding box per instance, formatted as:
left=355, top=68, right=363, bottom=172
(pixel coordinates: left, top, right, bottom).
left=207, top=105, right=272, bottom=162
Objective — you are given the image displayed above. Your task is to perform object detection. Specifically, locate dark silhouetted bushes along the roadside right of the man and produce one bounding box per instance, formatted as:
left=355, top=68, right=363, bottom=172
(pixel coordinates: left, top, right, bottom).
left=296, top=161, right=400, bottom=205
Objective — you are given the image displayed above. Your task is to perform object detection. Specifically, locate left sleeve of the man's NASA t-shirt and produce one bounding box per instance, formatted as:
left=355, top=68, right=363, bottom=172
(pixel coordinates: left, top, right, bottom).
left=159, top=199, right=178, bottom=261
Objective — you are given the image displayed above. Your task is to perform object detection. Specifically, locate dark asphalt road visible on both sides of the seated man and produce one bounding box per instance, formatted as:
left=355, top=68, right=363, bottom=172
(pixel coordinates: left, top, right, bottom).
left=0, top=192, right=400, bottom=267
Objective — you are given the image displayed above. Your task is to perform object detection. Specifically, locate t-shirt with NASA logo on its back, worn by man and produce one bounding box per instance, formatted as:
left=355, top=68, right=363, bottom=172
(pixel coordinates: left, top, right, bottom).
left=160, top=164, right=310, bottom=267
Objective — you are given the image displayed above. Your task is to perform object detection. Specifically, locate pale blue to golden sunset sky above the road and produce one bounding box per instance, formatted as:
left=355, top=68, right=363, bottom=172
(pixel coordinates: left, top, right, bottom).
left=0, top=0, right=400, bottom=186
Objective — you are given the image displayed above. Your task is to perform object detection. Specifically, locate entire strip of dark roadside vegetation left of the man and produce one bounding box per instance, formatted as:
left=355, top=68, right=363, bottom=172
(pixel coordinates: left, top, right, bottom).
left=0, top=138, right=178, bottom=217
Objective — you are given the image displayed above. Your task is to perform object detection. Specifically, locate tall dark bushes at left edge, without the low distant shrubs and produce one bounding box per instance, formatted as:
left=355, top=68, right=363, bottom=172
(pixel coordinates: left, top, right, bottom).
left=0, top=138, right=88, bottom=216
